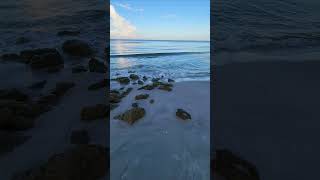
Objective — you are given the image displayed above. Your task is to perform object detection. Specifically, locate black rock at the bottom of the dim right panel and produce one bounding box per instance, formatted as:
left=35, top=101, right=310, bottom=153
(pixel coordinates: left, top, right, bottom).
left=212, top=149, right=260, bottom=180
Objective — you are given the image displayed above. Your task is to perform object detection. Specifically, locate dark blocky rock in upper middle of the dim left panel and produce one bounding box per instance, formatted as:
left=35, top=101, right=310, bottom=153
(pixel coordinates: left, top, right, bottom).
left=29, top=51, right=64, bottom=69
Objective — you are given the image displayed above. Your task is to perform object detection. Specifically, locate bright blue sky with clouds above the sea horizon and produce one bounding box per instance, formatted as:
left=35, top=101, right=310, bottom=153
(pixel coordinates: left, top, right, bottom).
left=110, top=0, right=210, bottom=40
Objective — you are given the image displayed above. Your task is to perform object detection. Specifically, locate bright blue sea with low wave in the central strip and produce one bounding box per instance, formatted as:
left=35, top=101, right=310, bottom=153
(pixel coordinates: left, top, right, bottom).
left=110, top=40, right=210, bottom=81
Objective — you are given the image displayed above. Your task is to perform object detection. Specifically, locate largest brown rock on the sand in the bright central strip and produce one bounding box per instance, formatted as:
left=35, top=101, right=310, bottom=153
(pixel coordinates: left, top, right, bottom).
left=114, top=107, right=146, bottom=125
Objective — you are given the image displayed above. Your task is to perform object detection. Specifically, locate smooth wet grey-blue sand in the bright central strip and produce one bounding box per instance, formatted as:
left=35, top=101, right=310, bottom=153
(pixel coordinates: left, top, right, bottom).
left=110, top=81, right=210, bottom=180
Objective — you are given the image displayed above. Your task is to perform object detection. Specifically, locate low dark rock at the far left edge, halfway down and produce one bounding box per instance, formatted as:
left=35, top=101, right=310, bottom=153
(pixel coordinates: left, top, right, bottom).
left=0, top=88, right=29, bottom=101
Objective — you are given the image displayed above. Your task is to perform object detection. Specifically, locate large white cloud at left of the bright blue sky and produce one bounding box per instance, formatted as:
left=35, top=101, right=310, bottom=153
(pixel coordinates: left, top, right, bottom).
left=110, top=4, right=137, bottom=39
